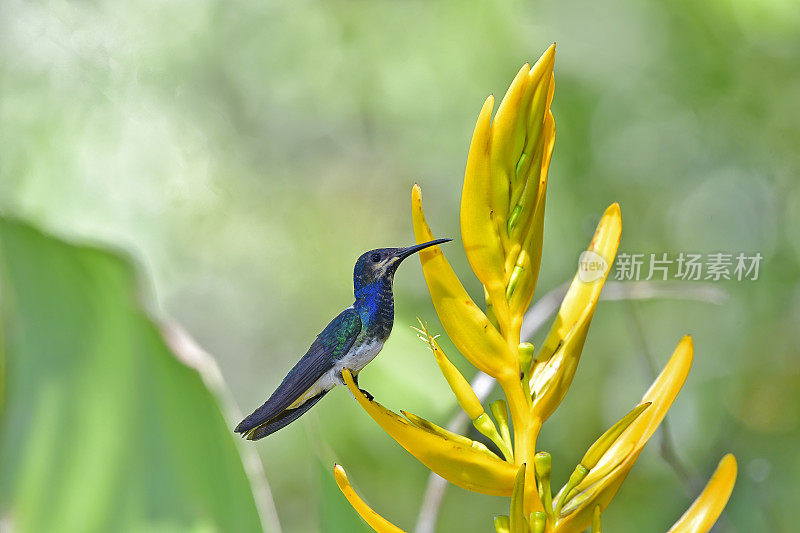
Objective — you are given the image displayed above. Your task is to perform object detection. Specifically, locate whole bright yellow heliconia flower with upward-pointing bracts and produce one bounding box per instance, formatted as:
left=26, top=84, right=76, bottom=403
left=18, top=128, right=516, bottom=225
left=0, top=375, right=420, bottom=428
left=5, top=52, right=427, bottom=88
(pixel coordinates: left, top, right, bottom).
left=336, top=45, right=736, bottom=533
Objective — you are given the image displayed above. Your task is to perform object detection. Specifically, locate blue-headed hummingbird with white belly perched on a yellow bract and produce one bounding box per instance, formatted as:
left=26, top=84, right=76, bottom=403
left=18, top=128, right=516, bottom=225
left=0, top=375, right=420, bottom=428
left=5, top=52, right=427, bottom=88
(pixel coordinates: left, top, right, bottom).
left=234, top=239, right=452, bottom=440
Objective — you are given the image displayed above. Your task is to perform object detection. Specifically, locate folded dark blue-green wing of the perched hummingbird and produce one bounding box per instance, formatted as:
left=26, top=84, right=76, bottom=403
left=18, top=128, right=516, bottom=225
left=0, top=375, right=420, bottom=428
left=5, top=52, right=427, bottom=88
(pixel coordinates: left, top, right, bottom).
left=235, top=307, right=361, bottom=433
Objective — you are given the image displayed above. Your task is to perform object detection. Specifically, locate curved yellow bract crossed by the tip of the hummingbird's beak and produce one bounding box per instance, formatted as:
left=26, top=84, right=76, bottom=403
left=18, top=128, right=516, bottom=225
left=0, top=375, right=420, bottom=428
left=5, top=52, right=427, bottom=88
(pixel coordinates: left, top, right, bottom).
left=411, top=185, right=516, bottom=378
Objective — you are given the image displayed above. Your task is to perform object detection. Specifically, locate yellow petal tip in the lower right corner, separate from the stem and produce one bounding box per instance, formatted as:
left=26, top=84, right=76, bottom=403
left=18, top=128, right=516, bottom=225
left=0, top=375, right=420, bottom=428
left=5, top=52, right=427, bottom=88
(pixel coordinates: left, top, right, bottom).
left=668, top=454, right=736, bottom=533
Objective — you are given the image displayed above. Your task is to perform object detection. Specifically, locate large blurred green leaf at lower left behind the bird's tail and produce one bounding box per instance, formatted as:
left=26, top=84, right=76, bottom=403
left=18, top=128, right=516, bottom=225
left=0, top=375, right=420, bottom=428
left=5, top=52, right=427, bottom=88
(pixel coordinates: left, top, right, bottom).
left=0, top=219, right=268, bottom=532
